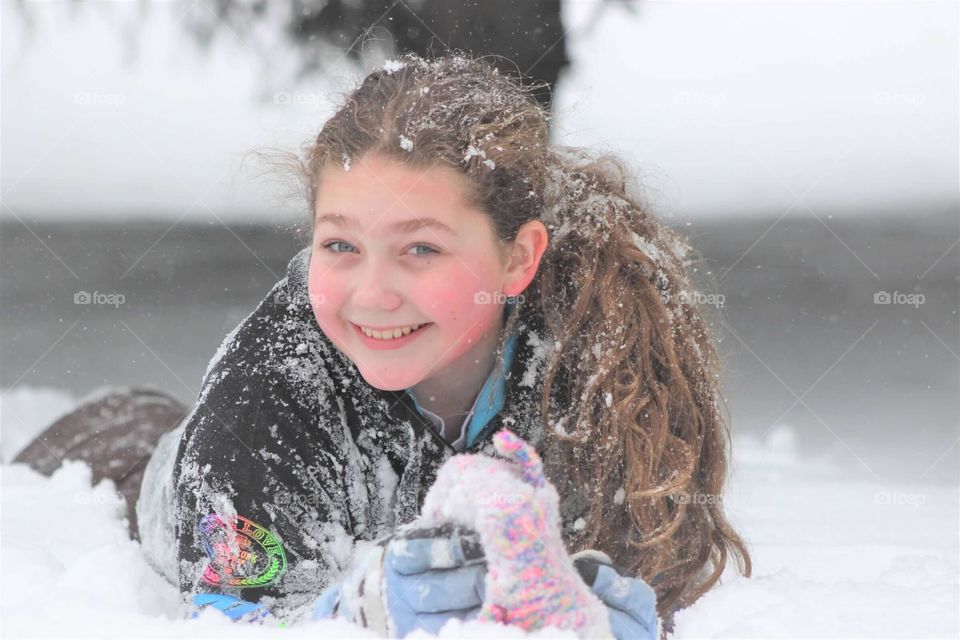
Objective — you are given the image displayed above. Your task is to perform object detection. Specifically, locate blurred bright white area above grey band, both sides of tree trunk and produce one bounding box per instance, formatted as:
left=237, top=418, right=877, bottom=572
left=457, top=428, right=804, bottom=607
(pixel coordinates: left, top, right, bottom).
left=0, top=0, right=960, bottom=220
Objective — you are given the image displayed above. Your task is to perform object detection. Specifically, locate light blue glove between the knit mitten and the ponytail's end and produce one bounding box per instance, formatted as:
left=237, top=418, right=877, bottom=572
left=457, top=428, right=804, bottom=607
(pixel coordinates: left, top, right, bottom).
left=571, top=549, right=660, bottom=640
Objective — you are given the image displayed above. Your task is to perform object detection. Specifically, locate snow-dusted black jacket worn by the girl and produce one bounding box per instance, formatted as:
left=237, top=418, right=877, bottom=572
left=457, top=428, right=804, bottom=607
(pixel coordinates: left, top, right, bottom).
left=173, top=249, right=585, bottom=618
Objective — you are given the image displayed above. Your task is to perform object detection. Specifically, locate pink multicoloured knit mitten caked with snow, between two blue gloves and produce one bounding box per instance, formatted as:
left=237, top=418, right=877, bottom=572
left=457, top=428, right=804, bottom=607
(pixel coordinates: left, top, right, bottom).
left=417, top=429, right=612, bottom=638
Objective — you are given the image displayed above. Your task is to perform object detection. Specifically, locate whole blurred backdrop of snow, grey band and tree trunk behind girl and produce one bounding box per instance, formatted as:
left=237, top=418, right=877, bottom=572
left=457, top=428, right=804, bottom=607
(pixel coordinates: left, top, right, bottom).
left=0, top=0, right=960, bottom=492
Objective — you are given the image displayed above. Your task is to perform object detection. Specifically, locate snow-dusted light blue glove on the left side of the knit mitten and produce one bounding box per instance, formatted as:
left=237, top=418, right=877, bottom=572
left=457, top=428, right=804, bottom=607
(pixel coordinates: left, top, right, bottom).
left=313, top=525, right=487, bottom=638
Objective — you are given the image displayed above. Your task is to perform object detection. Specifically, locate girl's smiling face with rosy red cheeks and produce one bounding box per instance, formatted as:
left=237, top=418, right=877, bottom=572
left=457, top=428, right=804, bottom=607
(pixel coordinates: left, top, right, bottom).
left=309, top=155, right=539, bottom=391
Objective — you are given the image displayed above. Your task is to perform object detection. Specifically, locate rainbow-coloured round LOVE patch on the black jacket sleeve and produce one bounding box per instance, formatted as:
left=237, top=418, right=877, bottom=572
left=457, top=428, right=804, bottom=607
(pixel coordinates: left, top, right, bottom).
left=197, top=513, right=287, bottom=587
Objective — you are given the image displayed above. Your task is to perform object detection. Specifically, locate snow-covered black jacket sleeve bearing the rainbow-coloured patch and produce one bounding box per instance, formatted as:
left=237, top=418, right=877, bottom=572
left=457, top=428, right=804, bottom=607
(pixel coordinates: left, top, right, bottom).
left=174, top=278, right=354, bottom=619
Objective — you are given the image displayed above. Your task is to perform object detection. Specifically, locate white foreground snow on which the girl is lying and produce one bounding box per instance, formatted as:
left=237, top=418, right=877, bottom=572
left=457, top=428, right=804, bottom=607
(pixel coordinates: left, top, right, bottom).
left=0, top=387, right=960, bottom=638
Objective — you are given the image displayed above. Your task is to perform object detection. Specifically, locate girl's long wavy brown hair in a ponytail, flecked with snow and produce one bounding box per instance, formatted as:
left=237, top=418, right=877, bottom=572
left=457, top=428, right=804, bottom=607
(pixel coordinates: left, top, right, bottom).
left=301, top=54, right=751, bottom=617
